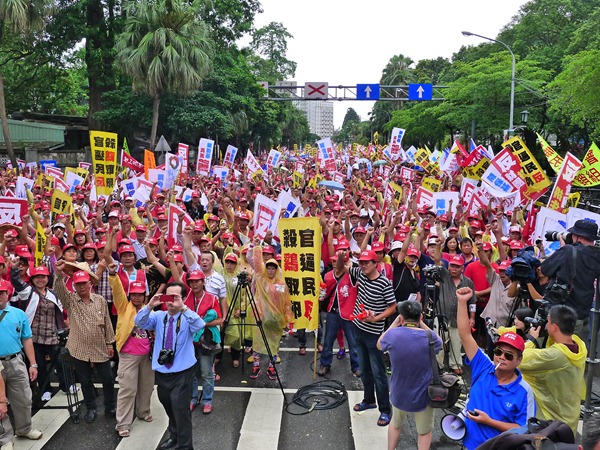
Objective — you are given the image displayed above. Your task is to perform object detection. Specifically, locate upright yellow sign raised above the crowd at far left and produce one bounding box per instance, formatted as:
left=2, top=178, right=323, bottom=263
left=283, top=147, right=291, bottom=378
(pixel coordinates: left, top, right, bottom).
left=90, top=131, right=118, bottom=196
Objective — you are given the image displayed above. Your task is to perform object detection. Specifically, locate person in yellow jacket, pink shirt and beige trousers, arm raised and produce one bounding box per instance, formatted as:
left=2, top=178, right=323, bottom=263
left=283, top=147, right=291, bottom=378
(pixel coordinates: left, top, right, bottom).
left=108, top=263, right=154, bottom=437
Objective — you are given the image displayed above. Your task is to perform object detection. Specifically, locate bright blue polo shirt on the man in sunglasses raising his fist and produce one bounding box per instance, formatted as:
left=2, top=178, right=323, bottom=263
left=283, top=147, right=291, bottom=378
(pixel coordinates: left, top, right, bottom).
left=463, top=349, right=536, bottom=450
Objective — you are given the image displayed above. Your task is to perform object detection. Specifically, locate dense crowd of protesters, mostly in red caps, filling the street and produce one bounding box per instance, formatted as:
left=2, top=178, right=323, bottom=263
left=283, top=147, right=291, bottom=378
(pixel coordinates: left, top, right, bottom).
left=0, top=147, right=600, bottom=449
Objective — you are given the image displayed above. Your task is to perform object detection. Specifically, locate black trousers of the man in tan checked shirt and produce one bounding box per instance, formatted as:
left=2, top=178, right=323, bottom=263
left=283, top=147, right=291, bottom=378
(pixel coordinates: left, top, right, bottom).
left=72, top=358, right=115, bottom=411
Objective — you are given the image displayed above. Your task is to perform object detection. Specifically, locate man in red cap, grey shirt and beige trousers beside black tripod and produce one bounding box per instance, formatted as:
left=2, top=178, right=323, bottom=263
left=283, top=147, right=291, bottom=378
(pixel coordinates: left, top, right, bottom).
left=429, top=239, right=477, bottom=375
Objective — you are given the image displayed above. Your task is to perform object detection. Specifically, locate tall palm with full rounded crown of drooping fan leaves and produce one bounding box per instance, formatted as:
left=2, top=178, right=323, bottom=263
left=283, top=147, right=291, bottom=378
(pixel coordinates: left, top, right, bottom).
left=116, top=0, right=213, bottom=150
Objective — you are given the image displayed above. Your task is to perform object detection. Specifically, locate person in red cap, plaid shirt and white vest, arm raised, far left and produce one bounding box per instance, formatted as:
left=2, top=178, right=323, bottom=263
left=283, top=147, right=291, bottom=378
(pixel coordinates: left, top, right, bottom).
left=11, top=258, right=69, bottom=402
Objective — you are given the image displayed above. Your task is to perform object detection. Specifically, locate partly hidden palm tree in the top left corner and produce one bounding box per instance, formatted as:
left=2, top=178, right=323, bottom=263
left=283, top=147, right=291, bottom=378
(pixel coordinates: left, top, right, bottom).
left=0, top=0, right=52, bottom=173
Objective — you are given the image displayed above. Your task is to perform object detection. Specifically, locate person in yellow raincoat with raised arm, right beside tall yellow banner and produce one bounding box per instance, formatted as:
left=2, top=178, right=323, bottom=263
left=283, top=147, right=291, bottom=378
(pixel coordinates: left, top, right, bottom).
left=250, top=238, right=292, bottom=380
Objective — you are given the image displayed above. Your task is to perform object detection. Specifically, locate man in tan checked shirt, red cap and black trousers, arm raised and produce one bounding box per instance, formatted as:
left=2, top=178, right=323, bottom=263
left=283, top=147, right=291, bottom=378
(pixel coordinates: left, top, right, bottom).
left=54, top=261, right=115, bottom=423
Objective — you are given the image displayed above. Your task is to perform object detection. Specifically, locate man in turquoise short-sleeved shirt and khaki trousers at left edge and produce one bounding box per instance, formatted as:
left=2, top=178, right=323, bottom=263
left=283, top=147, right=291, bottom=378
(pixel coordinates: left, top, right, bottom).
left=0, top=280, right=42, bottom=450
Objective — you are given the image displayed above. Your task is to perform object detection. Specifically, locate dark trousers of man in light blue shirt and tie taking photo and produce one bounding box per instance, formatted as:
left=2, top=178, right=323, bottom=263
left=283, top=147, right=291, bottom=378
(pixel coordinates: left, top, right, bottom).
left=155, top=366, right=195, bottom=450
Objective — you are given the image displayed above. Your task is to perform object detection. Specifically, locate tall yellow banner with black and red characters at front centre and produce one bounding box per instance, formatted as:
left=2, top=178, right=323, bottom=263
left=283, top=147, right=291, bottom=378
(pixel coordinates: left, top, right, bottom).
left=277, top=217, right=321, bottom=331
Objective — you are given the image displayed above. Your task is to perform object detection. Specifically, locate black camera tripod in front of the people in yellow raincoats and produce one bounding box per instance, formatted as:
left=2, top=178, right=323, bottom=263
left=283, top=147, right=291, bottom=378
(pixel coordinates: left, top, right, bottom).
left=222, top=272, right=287, bottom=400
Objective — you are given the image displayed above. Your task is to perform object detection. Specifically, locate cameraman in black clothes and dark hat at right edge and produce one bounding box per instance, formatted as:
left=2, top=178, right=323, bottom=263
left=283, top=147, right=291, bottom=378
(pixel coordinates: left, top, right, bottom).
left=541, top=219, right=600, bottom=342
